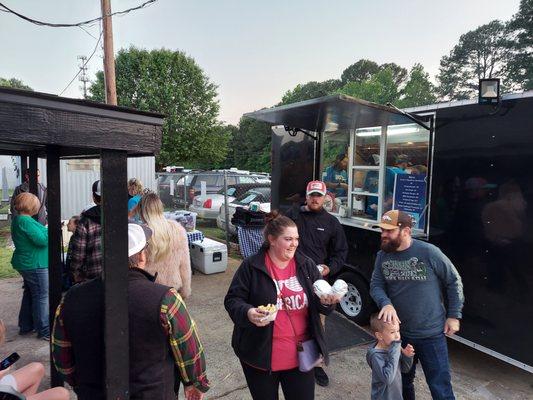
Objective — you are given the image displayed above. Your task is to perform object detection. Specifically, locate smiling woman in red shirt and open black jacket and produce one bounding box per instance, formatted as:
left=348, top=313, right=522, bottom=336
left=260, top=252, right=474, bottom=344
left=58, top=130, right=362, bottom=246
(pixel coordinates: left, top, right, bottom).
left=224, top=212, right=335, bottom=400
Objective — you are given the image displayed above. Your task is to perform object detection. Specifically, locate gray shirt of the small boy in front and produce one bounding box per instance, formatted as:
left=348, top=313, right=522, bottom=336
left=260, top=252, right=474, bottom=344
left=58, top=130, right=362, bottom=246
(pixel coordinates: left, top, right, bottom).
left=366, top=341, right=413, bottom=400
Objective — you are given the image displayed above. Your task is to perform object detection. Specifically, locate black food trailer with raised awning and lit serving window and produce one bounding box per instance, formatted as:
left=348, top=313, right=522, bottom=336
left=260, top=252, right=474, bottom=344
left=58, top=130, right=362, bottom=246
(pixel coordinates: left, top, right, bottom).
left=247, top=92, right=533, bottom=372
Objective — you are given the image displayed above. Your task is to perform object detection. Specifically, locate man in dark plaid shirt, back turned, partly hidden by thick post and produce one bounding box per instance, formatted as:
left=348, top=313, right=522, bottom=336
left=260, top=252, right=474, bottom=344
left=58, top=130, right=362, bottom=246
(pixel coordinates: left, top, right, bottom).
left=68, top=181, right=102, bottom=283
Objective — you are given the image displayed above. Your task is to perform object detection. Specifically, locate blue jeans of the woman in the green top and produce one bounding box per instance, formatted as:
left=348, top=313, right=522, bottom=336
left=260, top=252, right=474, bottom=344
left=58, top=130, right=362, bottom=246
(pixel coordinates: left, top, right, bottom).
left=19, top=268, right=50, bottom=337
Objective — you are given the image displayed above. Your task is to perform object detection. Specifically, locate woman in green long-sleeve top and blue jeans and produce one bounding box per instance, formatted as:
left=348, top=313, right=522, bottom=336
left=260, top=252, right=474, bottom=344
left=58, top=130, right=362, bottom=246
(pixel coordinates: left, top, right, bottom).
left=11, top=192, right=50, bottom=340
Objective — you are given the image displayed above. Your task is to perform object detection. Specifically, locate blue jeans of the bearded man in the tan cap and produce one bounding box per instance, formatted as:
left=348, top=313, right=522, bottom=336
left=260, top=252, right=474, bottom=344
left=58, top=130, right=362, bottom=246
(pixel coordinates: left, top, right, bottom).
left=402, top=333, right=455, bottom=400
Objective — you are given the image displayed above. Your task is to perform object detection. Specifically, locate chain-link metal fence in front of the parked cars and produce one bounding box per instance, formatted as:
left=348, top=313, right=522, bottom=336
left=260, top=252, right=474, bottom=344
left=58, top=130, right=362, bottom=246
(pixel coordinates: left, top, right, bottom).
left=157, top=170, right=270, bottom=253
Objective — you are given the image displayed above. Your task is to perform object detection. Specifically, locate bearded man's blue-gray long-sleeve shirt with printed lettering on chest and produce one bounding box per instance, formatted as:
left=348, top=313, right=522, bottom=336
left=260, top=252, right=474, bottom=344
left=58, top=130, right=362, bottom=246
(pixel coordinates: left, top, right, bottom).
left=370, top=239, right=464, bottom=339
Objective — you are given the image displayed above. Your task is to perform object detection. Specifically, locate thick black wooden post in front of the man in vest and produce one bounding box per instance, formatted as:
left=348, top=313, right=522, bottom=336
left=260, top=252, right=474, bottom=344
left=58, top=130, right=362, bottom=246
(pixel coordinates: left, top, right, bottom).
left=100, top=150, right=129, bottom=400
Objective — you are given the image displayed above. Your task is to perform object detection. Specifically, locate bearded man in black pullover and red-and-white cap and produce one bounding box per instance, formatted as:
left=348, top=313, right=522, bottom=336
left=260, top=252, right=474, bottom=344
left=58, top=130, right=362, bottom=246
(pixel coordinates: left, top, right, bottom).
left=287, top=181, right=348, bottom=386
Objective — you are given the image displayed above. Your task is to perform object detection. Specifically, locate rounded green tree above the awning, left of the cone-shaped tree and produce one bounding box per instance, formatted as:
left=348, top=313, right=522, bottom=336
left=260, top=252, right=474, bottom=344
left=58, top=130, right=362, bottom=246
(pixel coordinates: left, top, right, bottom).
left=338, top=68, right=400, bottom=104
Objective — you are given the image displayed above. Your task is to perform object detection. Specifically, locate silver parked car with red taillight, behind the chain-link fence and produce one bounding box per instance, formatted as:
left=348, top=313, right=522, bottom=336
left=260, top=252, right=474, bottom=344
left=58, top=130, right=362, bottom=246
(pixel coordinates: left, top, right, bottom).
left=189, top=182, right=270, bottom=219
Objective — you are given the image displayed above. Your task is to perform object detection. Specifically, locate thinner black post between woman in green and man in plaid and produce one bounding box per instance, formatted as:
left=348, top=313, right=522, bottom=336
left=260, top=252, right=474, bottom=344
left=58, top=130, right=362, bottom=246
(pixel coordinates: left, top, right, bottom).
left=46, top=146, right=63, bottom=387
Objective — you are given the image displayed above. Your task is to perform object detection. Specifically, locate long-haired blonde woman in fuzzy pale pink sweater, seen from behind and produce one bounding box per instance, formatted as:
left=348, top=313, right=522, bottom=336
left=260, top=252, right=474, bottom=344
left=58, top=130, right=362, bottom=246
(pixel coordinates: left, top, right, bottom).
left=138, top=192, right=191, bottom=298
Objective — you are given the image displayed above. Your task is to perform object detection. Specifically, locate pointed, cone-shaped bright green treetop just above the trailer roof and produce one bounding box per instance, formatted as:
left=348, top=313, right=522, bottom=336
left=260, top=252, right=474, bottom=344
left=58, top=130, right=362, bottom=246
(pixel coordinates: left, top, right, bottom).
left=395, top=64, right=437, bottom=108
